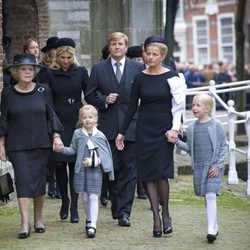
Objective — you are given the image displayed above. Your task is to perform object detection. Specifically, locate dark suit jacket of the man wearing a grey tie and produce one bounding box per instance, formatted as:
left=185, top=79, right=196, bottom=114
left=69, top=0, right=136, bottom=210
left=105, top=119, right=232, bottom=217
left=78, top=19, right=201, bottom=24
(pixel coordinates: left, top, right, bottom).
left=85, top=58, right=143, bottom=141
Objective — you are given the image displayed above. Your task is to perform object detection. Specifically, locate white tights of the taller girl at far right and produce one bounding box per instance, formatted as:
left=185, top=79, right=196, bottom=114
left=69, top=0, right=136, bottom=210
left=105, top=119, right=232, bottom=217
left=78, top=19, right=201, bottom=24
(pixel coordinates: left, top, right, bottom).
left=205, top=193, right=218, bottom=235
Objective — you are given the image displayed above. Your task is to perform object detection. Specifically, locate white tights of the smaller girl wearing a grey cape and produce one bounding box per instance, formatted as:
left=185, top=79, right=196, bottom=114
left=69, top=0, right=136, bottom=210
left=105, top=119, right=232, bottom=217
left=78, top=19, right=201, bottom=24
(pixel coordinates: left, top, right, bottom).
left=82, top=192, right=99, bottom=228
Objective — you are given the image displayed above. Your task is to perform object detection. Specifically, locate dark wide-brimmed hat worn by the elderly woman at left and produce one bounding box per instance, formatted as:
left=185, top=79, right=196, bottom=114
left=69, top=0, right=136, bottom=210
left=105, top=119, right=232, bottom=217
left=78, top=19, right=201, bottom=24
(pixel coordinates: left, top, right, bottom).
left=6, top=53, right=46, bottom=70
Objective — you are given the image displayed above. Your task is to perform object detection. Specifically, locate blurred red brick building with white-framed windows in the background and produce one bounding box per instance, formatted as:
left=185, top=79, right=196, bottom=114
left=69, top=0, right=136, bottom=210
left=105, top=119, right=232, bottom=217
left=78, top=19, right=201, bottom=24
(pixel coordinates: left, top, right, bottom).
left=175, top=0, right=250, bottom=65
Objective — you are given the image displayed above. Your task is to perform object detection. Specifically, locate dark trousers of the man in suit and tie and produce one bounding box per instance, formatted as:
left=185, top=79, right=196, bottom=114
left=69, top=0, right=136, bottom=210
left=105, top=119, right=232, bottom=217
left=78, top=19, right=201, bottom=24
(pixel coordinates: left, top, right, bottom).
left=109, top=141, right=137, bottom=219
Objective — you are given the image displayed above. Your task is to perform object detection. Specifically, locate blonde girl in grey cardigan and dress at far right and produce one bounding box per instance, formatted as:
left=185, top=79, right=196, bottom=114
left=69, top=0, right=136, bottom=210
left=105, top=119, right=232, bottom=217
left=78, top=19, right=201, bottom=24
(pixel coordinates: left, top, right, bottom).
left=176, top=94, right=227, bottom=243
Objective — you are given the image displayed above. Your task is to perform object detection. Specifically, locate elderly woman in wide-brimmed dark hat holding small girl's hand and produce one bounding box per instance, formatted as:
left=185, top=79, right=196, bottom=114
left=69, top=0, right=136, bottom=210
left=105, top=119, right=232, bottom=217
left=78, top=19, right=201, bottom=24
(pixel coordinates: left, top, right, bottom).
left=0, top=54, right=63, bottom=239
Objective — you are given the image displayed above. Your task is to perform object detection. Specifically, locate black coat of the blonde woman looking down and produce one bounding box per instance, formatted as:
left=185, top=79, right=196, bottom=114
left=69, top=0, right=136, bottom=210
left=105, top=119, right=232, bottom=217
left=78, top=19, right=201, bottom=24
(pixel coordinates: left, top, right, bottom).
left=47, top=65, right=89, bottom=162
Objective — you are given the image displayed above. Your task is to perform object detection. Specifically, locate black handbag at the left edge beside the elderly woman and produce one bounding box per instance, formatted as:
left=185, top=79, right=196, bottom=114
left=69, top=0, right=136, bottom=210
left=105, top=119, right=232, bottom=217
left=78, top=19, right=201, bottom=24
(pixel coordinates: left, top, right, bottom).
left=0, top=173, right=14, bottom=202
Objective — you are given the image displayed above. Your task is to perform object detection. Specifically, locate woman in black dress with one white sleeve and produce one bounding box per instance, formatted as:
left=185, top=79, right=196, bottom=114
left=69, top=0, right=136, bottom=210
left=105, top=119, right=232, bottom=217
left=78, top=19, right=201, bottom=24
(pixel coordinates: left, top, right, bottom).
left=116, top=35, right=186, bottom=237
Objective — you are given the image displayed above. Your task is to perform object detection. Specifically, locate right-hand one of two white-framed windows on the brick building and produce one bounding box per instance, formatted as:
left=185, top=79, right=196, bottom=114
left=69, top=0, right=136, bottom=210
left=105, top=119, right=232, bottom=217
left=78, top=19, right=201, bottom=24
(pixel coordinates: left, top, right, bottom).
left=217, top=14, right=235, bottom=63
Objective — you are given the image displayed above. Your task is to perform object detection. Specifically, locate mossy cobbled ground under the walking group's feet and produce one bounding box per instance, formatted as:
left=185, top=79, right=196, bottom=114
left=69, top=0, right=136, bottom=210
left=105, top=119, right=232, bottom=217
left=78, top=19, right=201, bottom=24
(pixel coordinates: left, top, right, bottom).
left=0, top=112, right=250, bottom=250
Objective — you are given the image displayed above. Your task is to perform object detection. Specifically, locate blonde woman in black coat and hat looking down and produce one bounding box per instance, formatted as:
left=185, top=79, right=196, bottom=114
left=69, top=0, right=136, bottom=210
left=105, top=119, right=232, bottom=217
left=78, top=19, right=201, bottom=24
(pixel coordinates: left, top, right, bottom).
left=48, top=38, right=89, bottom=223
